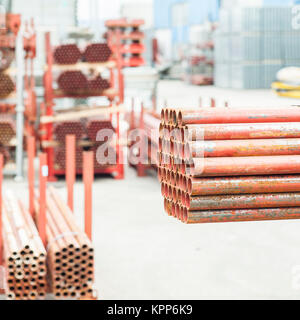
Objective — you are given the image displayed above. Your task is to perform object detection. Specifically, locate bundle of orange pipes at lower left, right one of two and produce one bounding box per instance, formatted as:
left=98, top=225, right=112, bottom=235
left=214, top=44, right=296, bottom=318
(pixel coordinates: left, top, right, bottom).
left=35, top=188, right=94, bottom=299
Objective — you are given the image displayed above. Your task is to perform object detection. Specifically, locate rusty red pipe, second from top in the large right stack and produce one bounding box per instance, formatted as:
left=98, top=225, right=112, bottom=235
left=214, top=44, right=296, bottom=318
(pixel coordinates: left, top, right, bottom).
left=181, top=122, right=300, bottom=142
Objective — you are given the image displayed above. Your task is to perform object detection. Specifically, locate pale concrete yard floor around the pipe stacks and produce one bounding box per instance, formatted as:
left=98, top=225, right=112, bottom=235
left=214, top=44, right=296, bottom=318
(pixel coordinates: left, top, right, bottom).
left=5, top=81, right=300, bottom=299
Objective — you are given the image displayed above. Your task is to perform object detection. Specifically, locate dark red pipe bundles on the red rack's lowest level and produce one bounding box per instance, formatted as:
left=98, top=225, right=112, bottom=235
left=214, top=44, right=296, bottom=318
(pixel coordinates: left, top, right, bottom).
left=54, top=117, right=118, bottom=172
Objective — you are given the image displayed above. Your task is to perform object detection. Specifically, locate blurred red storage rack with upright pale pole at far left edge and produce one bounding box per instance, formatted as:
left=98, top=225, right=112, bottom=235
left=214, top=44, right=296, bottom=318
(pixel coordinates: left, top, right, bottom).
left=0, top=14, right=35, bottom=181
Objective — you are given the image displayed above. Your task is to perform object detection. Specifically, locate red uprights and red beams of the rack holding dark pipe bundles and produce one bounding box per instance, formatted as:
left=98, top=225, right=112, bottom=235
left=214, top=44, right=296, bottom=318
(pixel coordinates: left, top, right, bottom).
left=41, top=33, right=124, bottom=181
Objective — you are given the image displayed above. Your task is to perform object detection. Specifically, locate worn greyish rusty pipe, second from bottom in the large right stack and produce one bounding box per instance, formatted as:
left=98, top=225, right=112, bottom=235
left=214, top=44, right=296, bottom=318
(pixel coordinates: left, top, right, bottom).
left=184, top=193, right=300, bottom=211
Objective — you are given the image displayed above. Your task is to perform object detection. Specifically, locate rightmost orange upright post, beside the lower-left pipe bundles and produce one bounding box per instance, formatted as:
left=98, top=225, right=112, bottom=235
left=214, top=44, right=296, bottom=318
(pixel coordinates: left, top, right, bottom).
left=83, top=151, right=94, bottom=240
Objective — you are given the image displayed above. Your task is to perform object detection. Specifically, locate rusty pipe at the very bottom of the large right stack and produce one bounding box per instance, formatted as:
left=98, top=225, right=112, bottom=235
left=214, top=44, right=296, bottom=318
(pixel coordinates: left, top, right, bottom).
left=183, top=208, right=300, bottom=224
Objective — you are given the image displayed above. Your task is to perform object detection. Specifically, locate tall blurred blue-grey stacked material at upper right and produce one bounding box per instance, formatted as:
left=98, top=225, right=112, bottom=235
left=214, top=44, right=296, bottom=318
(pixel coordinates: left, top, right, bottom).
left=214, top=7, right=300, bottom=89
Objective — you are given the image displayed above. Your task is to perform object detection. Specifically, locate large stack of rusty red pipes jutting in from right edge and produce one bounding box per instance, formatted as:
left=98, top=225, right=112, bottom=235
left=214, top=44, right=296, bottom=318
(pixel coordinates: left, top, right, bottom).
left=158, top=107, right=300, bottom=223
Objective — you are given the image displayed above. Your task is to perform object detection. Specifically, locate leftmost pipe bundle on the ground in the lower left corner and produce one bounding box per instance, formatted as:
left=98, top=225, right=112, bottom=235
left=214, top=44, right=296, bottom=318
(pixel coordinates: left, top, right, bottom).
left=2, top=191, right=47, bottom=300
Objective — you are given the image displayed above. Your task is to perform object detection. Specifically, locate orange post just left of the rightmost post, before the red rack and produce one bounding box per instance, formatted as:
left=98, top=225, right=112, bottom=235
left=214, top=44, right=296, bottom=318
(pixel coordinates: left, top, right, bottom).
left=66, top=135, right=76, bottom=211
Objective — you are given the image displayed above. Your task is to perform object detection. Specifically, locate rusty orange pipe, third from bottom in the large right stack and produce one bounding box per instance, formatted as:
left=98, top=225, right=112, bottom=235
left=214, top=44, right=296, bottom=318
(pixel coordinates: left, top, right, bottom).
left=185, top=175, right=300, bottom=196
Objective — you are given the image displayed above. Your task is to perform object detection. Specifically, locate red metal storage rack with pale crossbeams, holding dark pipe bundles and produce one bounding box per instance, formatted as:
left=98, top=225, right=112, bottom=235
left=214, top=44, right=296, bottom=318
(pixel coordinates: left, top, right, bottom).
left=41, top=33, right=124, bottom=181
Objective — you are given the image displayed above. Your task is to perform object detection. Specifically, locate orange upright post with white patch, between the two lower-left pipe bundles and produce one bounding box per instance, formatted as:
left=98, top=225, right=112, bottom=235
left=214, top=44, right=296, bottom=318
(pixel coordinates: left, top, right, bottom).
left=37, top=153, right=49, bottom=247
